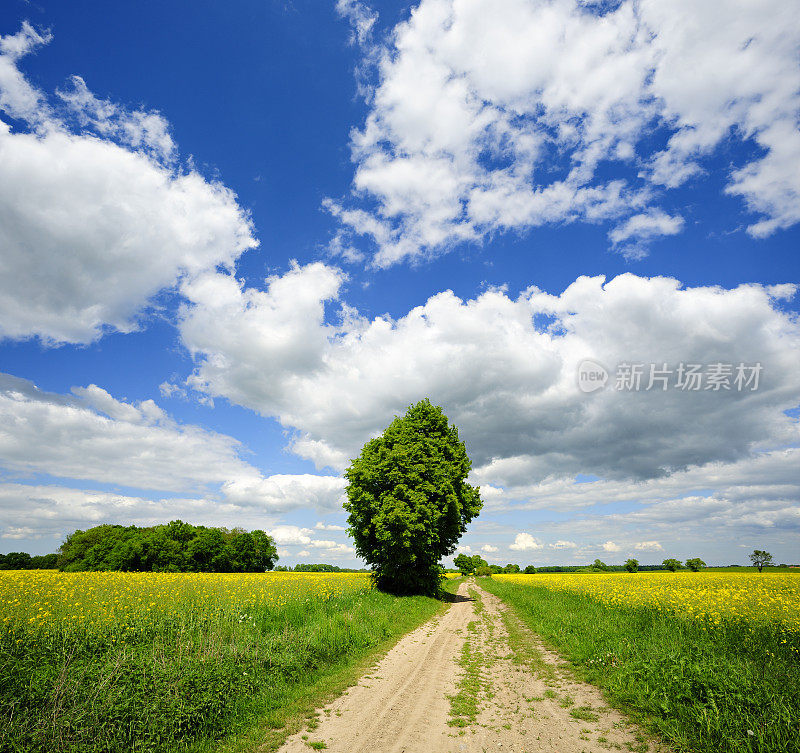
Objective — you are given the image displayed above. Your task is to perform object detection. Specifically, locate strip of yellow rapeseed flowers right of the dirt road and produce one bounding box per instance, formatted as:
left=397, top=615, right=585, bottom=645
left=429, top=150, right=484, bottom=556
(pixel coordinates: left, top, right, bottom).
left=494, top=572, right=800, bottom=633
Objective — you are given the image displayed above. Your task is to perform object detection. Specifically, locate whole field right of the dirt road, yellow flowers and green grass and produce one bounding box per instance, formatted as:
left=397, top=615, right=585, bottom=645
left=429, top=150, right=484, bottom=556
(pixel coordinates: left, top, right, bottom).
left=481, top=572, right=800, bottom=753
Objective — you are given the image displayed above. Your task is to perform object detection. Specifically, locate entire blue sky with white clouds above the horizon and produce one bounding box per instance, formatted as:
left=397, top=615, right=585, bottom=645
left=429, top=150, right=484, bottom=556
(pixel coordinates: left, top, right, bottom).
left=0, top=0, right=800, bottom=566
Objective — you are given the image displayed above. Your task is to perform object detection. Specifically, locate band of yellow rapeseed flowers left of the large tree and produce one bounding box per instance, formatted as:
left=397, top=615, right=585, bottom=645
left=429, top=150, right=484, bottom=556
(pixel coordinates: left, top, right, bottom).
left=0, top=570, right=371, bottom=639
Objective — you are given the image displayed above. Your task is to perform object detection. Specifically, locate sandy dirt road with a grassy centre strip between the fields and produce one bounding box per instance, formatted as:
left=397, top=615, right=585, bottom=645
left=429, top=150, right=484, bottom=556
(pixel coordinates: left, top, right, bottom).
left=280, top=581, right=662, bottom=753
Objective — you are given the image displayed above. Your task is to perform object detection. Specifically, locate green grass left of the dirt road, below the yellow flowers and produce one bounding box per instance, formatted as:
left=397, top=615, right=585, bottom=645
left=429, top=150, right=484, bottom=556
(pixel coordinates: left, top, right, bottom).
left=0, top=591, right=443, bottom=753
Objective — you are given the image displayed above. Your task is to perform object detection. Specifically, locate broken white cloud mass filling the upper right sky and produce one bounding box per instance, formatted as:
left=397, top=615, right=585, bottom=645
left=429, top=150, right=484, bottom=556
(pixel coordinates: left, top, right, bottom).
left=326, top=0, right=800, bottom=266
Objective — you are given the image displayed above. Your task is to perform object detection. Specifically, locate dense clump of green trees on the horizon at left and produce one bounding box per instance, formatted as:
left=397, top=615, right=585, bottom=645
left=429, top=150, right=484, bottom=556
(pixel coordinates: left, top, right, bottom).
left=58, top=520, right=278, bottom=573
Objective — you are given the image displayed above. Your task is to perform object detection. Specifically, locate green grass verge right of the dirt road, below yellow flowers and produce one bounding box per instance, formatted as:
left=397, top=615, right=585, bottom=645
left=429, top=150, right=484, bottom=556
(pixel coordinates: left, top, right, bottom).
left=481, top=578, right=800, bottom=753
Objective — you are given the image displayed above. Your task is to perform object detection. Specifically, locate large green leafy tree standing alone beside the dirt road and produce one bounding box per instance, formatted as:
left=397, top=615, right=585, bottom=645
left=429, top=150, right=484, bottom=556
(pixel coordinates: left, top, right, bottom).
left=344, top=399, right=482, bottom=595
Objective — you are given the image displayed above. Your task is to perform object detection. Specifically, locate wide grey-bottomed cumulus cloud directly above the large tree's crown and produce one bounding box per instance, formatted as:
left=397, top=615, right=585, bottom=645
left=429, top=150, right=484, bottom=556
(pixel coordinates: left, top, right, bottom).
left=181, top=264, right=800, bottom=484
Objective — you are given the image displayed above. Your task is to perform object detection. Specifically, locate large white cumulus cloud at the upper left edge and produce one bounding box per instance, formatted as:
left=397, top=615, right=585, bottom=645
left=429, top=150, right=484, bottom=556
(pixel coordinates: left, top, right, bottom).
left=0, top=23, right=257, bottom=344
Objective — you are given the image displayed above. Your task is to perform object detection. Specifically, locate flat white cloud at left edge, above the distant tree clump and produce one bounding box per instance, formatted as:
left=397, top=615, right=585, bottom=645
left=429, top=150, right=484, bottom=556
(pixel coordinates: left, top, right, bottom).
left=0, top=374, right=258, bottom=491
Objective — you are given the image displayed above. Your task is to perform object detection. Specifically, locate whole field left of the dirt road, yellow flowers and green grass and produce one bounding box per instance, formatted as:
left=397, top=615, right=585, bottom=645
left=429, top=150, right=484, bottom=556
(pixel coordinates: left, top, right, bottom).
left=0, top=570, right=440, bottom=751
